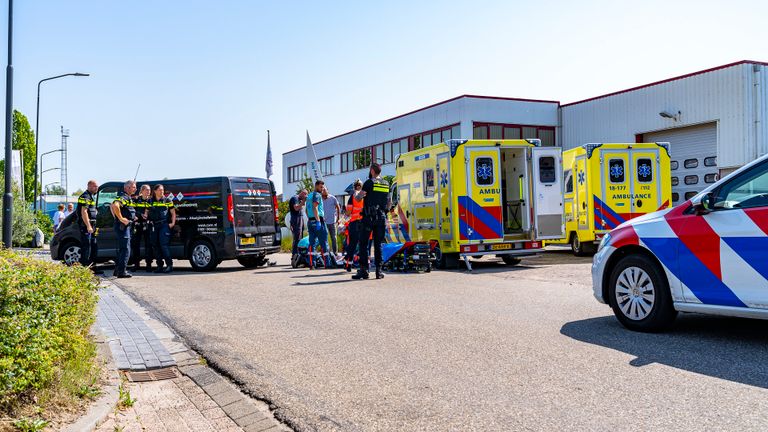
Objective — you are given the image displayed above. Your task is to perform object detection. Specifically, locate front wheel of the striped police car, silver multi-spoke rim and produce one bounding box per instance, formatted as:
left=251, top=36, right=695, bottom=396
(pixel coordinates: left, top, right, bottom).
left=608, top=255, right=677, bottom=332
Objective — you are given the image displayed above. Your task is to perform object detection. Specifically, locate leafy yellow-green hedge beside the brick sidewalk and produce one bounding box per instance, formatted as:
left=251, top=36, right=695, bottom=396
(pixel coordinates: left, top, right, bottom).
left=0, top=250, right=97, bottom=413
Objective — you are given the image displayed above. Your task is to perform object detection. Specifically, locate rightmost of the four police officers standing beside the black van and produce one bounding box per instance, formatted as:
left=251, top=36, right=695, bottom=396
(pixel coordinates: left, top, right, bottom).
left=149, top=184, right=176, bottom=273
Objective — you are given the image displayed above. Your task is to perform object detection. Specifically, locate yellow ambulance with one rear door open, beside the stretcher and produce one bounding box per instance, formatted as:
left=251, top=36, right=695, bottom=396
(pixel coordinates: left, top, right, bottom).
left=388, top=140, right=563, bottom=269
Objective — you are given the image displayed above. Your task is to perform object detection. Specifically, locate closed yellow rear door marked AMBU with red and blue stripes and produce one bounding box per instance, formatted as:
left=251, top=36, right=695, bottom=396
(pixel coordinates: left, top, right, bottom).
left=458, top=146, right=504, bottom=244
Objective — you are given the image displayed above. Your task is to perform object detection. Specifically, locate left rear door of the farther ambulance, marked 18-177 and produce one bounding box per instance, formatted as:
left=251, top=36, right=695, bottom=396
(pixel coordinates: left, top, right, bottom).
left=594, top=148, right=633, bottom=231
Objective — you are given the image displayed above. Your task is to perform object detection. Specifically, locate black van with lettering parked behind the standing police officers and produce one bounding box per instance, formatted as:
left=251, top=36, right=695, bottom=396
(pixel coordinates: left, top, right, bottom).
left=51, top=177, right=280, bottom=271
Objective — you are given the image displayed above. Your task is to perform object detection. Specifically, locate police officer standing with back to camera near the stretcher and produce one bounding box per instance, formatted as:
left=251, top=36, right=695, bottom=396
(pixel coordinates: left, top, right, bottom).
left=352, top=162, right=389, bottom=279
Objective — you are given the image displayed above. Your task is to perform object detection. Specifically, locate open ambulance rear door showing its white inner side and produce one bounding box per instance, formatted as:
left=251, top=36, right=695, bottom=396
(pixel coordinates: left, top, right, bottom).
left=531, top=147, right=565, bottom=240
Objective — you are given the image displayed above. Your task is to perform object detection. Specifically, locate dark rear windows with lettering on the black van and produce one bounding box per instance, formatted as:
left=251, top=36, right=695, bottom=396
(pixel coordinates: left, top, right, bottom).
left=231, top=181, right=275, bottom=229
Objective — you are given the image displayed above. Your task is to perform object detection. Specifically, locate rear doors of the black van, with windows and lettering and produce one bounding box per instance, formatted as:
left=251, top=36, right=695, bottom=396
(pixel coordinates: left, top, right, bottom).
left=230, top=179, right=276, bottom=249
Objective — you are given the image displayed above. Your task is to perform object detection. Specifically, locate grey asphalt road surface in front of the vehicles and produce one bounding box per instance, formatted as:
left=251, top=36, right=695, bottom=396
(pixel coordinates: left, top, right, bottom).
left=112, top=251, right=768, bottom=431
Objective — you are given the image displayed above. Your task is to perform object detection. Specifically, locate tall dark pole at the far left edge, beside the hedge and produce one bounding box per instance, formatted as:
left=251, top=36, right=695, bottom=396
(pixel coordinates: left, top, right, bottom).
left=3, top=0, right=13, bottom=249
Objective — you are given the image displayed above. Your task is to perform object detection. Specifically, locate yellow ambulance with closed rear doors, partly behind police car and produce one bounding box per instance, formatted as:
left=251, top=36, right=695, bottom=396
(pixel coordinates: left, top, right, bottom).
left=547, top=143, right=672, bottom=256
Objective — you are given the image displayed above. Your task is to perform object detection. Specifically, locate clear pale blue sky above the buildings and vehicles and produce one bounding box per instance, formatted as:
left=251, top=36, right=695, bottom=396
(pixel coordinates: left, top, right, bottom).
left=0, top=0, right=768, bottom=190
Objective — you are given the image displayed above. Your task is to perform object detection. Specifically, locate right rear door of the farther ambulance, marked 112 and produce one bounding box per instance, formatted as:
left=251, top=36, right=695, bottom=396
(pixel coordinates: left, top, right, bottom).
left=631, top=147, right=662, bottom=217
